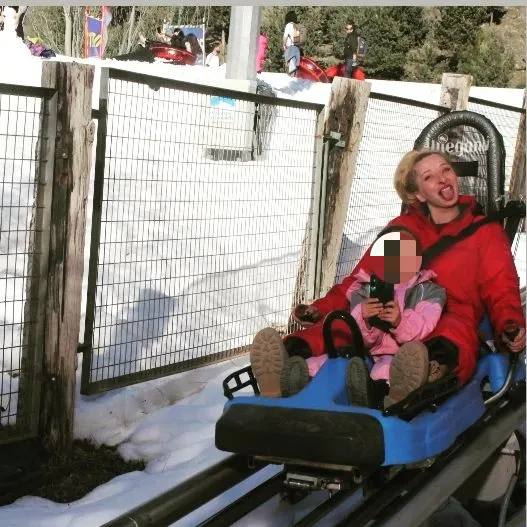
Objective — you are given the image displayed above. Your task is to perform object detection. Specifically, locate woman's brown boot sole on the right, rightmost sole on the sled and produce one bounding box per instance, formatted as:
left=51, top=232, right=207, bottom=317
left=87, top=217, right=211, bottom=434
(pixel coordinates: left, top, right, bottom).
left=384, top=341, right=429, bottom=408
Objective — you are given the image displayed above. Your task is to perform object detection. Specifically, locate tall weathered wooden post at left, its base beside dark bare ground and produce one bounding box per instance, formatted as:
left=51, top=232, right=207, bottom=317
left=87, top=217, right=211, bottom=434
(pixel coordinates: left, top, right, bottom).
left=40, top=62, right=94, bottom=452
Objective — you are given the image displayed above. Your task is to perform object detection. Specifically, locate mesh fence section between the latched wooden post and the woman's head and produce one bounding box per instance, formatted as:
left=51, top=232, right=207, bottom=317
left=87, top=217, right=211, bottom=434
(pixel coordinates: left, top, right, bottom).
left=335, top=93, right=447, bottom=283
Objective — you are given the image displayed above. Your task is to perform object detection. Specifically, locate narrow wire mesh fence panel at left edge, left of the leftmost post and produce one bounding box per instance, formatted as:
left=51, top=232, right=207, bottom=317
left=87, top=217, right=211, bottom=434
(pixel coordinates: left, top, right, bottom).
left=0, top=85, right=50, bottom=442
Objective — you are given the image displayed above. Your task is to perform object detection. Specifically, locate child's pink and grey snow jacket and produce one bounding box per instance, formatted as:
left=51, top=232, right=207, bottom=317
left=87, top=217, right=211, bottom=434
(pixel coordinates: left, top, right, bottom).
left=346, top=269, right=446, bottom=379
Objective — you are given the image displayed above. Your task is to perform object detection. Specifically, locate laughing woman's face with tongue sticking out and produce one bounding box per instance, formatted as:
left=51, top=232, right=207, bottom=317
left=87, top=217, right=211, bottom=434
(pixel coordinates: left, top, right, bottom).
left=414, top=154, right=459, bottom=209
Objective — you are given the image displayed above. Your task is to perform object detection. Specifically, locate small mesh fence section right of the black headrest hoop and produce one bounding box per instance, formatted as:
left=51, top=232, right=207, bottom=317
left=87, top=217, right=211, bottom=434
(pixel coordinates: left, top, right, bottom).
left=467, top=97, right=525, bottom=192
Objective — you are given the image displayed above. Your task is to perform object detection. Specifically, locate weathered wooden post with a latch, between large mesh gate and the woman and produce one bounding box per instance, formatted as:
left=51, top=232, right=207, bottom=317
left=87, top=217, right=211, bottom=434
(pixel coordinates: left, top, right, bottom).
left=316, top=77, right=371, bottom=297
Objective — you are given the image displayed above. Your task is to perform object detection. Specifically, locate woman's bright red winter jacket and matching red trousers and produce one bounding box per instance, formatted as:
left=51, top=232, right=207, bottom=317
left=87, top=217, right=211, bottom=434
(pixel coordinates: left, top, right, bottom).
left=291, top=196, right=525, bottom=384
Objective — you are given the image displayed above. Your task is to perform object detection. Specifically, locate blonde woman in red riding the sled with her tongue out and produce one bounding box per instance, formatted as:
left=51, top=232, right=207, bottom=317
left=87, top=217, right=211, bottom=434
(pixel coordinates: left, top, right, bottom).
left=250, top=150, right=525, bottom=402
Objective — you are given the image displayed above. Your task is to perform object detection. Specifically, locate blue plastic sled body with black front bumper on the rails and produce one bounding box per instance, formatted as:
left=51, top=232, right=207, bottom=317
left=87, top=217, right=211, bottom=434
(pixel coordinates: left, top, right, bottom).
left=216, top=348, right=525, bottom=467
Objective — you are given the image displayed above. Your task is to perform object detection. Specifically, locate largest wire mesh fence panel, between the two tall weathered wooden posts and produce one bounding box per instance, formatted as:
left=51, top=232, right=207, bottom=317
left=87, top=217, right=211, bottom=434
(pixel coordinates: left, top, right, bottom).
left=82, top=71, right=321, bottom=393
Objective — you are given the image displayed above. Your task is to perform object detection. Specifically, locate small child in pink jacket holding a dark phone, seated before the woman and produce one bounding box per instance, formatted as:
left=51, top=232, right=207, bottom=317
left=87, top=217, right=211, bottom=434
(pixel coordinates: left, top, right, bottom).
left=281, top=228, right=446, bottom=407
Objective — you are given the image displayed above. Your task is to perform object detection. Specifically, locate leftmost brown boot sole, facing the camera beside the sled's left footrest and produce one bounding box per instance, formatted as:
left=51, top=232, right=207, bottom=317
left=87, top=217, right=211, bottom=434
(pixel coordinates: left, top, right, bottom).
left=250, top=328, right=288, bottom=397
